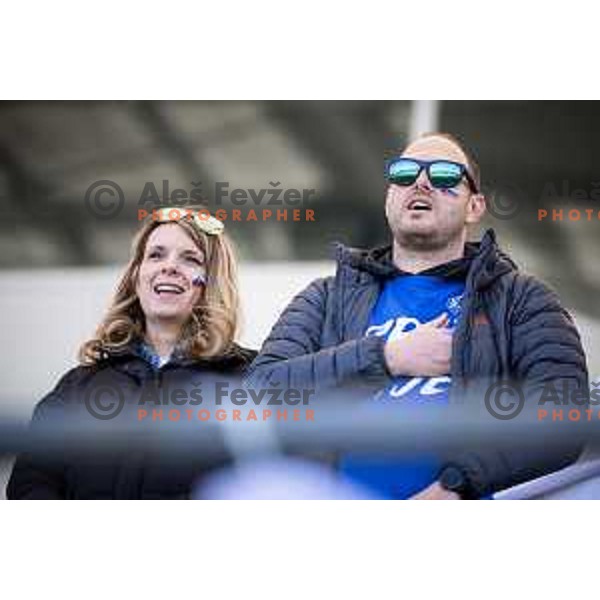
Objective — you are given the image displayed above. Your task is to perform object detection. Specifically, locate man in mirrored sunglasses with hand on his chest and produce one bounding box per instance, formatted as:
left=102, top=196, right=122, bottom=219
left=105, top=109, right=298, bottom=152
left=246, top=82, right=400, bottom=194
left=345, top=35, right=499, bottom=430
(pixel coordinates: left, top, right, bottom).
left=251, top=134, right=587, bottom=499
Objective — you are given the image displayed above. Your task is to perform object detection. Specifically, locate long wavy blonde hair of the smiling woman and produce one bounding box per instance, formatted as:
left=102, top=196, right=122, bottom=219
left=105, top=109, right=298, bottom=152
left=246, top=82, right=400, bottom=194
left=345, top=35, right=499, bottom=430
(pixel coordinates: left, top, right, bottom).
left=78, top=209, right=239, bottom=365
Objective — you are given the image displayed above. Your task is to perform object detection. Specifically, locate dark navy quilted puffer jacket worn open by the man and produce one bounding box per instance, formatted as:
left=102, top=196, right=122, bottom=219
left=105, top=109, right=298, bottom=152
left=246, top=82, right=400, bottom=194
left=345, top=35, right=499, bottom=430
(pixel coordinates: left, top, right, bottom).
left=250, top=230, right=587, bottom=496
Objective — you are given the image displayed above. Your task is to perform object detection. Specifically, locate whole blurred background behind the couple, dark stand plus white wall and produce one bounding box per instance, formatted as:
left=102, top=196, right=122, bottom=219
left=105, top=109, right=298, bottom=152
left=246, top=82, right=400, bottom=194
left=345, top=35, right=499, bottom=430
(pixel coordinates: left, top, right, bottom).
left=0, top=101, right=600, bottom=496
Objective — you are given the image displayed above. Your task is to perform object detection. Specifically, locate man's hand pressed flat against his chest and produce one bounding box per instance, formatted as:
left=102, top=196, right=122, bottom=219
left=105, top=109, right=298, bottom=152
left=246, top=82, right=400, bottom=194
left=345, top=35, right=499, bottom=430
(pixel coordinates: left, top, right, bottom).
left=384, top=313, right=452, bottom=377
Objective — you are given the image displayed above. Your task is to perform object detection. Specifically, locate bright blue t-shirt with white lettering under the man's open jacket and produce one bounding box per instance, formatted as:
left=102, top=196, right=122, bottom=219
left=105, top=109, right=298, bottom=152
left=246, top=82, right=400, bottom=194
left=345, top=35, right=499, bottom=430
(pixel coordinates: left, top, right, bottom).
left=340, top=275, right=465, bottom=499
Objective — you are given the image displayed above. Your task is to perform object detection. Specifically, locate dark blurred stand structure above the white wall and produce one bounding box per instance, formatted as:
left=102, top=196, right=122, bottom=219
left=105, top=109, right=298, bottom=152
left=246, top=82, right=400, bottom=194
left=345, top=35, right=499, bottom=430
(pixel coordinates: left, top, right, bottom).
left=0, top=101, right=600, bottom=274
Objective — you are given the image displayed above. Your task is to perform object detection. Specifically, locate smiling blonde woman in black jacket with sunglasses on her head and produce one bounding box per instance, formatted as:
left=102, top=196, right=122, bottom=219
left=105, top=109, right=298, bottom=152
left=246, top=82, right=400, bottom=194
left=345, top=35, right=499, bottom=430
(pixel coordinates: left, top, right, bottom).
left=7, top=208, right=255, bottom=499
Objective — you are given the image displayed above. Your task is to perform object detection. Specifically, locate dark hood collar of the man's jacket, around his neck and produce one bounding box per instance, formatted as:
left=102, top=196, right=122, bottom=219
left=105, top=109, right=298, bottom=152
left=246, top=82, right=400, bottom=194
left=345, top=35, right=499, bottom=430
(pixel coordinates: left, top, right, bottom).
left=336, top=229, right=518, bottom=289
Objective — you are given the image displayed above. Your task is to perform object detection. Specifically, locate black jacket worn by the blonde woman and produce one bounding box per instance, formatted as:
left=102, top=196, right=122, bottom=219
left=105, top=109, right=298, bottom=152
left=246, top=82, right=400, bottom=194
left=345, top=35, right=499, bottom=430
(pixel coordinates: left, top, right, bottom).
left=6, top=346, right=256, bottom=499
